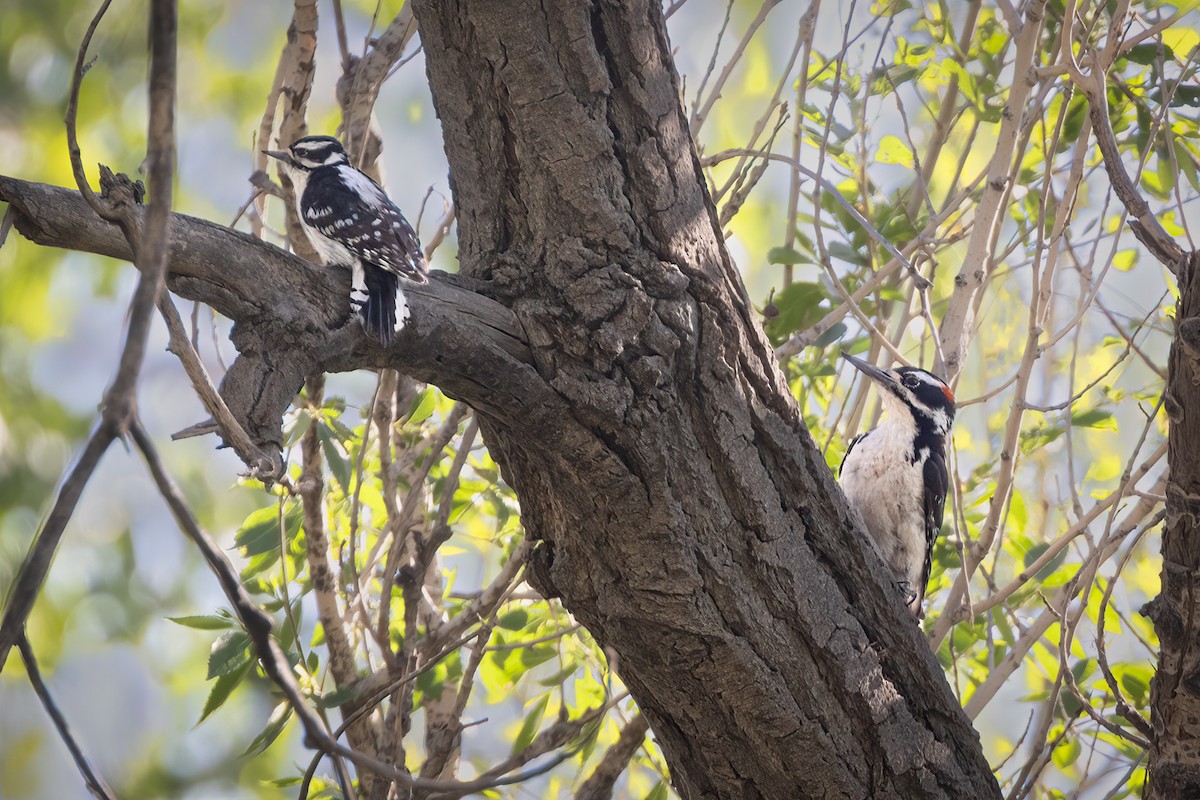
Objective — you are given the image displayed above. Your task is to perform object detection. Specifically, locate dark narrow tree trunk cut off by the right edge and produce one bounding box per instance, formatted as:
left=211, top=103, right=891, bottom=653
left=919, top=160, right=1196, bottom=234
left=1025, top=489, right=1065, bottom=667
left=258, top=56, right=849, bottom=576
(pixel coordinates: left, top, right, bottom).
left=1142, top=252, right=1200, bottom=800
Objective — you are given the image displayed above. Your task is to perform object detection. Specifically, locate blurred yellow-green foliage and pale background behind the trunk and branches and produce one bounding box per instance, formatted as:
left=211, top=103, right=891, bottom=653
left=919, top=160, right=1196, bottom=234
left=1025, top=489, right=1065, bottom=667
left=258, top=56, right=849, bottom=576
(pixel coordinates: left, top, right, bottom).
left=0, top=0, right=1200, bottom=800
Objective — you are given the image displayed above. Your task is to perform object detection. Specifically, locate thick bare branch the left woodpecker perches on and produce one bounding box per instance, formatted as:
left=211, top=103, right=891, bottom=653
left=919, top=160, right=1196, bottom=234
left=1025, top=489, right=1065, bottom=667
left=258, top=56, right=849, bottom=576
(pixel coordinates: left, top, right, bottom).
left=0, top=176, right=549, bottom=449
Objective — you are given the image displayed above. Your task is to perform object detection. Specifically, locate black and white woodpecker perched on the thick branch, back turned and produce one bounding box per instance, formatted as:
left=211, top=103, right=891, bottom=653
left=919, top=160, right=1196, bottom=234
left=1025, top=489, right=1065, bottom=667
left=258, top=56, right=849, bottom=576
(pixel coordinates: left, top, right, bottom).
left=263, top=136, right=428, bottom=345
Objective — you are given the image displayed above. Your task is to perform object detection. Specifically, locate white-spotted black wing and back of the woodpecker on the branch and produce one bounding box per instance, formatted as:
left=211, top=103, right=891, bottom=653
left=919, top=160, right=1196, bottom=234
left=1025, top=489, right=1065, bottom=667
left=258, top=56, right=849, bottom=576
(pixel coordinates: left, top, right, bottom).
left=300, top=164, right=428, bottom=283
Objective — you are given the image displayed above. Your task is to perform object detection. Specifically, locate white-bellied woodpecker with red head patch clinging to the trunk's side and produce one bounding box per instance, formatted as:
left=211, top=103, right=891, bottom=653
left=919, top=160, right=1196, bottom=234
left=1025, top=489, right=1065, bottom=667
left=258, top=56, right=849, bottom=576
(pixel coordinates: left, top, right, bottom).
left=838, top=353, right=954, bottom=618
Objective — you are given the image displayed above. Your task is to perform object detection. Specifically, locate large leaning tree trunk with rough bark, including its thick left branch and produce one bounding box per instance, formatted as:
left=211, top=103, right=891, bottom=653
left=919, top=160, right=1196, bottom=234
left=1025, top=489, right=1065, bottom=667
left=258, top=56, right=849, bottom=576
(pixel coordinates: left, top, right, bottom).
left=0, top=0, right=1000, bottom=800
